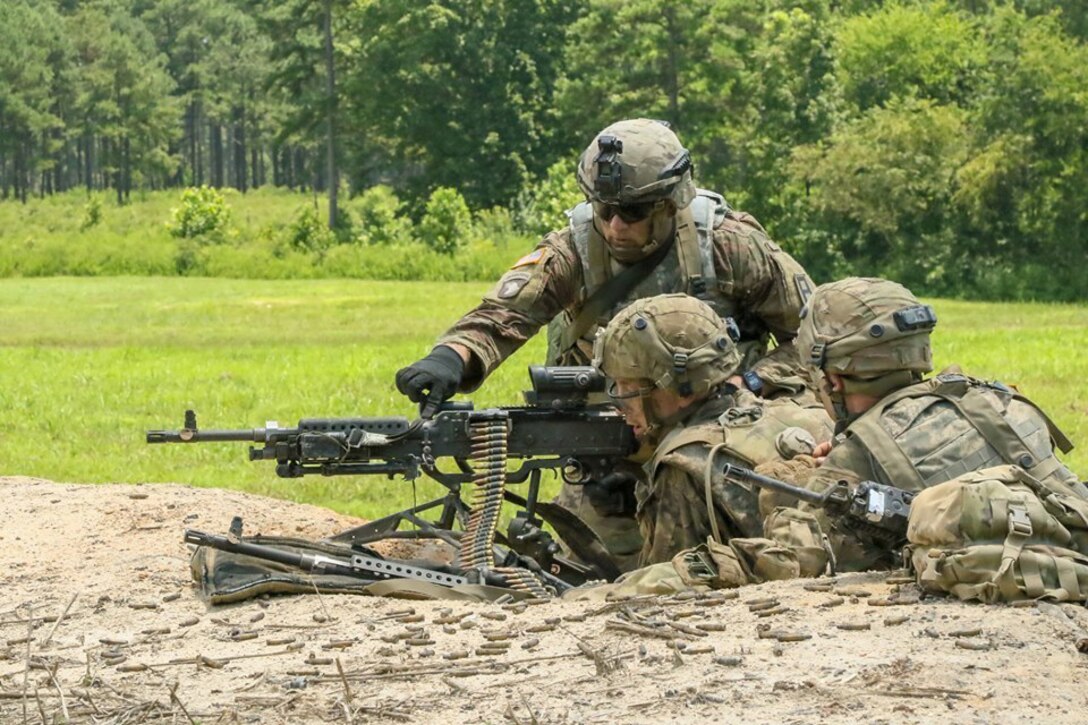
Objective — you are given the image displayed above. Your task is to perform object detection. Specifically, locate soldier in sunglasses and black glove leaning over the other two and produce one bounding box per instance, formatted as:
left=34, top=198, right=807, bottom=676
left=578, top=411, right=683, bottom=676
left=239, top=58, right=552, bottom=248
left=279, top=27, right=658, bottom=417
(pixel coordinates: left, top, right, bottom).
left=396, top=119, right=813, bottom=557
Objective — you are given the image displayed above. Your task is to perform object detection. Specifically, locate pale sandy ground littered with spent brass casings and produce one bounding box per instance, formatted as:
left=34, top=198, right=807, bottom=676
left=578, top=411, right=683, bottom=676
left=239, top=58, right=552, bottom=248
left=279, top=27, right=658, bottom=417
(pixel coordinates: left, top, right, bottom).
left=0, top=478, right=1088, bottom=724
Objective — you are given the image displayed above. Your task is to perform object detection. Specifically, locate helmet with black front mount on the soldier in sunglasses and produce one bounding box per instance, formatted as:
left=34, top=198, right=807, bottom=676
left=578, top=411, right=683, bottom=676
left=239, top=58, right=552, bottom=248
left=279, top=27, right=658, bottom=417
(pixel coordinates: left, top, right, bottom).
left=578, top=119, right=695, bottom=209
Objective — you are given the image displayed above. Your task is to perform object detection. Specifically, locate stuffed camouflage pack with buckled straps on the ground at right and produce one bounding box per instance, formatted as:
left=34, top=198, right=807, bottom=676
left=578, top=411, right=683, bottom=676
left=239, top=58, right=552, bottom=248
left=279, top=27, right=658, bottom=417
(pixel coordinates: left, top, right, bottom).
left=907, top=465, right=1088, bottom=603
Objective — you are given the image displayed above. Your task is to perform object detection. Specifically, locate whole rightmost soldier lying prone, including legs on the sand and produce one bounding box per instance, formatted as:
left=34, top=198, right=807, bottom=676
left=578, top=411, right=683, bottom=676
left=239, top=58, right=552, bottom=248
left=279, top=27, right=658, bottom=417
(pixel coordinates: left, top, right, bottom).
left=571, top=278, right=1088, bottom=599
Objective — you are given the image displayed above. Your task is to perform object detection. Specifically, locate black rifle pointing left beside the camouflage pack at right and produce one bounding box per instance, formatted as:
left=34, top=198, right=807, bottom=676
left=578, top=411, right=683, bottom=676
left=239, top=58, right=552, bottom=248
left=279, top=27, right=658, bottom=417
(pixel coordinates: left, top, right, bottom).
left=718, top=463, right=914, bottom=546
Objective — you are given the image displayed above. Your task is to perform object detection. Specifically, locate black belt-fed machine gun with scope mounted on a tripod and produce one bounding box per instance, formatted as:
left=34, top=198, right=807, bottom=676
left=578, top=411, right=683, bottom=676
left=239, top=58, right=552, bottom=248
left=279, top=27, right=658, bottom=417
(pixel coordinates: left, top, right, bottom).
left=147, top=366, right=638, bottom=589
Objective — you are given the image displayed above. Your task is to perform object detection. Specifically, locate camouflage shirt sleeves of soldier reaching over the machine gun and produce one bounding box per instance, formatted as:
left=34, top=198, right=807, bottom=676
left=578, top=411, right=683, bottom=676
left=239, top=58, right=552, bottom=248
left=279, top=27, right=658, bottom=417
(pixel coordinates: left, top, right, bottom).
left=436, top=202, right=812, bottom=392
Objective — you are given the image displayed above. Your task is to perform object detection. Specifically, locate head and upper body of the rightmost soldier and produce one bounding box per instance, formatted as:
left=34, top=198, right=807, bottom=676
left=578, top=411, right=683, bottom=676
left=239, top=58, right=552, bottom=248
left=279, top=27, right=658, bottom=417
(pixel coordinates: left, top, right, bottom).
left=787, top=278, right=1088, bottom=570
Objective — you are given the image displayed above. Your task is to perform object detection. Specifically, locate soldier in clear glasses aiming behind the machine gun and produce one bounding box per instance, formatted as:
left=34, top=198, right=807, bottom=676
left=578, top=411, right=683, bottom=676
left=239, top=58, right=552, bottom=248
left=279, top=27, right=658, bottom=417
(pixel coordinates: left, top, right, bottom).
left=593, top=295, right=831, bottom=566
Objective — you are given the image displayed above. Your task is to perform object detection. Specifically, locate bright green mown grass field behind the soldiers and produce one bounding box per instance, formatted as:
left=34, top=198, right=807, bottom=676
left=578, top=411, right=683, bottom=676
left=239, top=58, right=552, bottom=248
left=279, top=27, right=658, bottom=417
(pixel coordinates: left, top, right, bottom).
left=0, top=278, right=1088, bottom=525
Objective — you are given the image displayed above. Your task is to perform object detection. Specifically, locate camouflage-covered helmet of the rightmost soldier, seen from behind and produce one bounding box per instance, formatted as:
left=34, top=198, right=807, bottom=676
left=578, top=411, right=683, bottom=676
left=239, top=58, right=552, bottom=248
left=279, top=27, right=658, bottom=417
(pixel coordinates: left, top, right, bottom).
left=795, top=277, right=937, bottom=422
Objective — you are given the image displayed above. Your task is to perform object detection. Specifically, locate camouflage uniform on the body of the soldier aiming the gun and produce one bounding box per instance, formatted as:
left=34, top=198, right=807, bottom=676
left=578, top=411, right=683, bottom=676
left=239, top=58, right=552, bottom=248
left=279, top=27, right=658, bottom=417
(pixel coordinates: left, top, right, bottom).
left=636, top=391, right=831, bottom=566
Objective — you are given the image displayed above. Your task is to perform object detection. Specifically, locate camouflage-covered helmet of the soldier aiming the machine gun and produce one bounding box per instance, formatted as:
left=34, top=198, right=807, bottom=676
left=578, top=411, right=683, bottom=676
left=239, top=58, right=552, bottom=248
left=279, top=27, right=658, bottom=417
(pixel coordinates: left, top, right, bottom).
left=593, top=294, right=741, bottom=397
